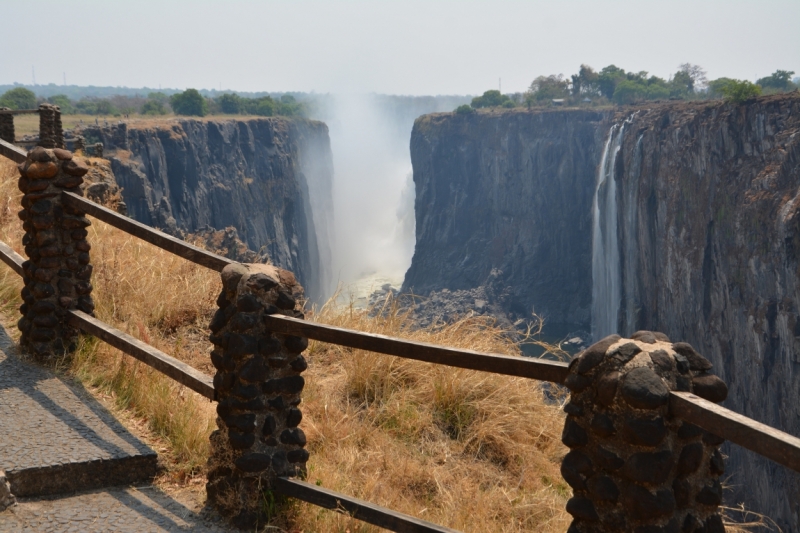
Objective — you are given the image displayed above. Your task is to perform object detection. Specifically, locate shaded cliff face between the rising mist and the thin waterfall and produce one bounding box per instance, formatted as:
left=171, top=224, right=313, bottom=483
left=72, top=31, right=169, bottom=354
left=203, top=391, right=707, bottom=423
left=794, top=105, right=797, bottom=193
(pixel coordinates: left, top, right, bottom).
left=403, top=111, right=606, bottom=326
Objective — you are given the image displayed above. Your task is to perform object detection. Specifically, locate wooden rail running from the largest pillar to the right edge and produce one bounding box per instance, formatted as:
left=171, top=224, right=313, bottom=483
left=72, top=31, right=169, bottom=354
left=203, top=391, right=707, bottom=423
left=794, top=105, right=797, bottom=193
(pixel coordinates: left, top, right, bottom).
left=669, top=392, right=800, bottom=472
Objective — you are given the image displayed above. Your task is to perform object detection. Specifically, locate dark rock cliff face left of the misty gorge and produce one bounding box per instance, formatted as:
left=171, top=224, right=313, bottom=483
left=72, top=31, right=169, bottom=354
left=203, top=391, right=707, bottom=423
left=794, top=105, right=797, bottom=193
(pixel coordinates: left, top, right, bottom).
left=84, top=118, right=333, bottom=299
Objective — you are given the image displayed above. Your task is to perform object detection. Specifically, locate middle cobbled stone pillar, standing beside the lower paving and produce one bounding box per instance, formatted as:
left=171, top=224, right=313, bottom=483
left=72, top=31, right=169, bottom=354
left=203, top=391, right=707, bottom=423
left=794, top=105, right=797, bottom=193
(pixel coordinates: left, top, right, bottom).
left=206, top=263, right=308, bottom=528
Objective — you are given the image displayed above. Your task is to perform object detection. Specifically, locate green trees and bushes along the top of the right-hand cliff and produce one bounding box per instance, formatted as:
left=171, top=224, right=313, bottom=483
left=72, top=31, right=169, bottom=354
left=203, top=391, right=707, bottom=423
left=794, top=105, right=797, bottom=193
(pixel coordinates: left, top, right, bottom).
left=456, top=63, right=800, bottom=113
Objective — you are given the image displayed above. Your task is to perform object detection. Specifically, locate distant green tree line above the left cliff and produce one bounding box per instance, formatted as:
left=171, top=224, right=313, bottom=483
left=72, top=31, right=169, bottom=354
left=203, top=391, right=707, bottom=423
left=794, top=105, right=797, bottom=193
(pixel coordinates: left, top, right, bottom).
left=0, top=87, right=308, bottom=117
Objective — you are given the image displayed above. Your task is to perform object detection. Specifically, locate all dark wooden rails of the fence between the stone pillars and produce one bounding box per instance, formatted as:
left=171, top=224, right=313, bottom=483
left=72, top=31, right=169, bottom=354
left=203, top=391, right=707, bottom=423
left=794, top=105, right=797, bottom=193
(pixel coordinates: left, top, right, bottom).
left=0, top=118, right=800, bottom=532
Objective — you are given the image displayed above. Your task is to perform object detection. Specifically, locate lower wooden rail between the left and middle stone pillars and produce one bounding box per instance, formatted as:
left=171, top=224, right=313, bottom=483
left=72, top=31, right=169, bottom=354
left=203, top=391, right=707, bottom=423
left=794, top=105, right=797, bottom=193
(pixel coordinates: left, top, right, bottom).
left=69, top=310, right=214, bottom=400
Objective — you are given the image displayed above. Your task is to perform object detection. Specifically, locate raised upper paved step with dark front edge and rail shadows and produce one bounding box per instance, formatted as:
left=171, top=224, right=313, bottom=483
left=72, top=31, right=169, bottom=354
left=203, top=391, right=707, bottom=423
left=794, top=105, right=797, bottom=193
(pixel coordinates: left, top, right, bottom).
left=0, top=327, right=157, bottom=496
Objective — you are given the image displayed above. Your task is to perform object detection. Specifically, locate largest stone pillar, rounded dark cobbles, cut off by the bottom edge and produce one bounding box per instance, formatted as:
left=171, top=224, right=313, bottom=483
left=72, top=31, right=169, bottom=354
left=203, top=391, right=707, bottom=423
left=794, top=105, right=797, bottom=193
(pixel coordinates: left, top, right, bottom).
left=561, top=331, right=728, bottom=533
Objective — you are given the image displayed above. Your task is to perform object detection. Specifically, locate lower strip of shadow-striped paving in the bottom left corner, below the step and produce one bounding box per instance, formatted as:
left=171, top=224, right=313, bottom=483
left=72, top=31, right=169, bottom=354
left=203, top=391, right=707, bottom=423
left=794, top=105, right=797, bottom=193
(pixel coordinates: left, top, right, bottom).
left=0, top=486, right=233, bottom=533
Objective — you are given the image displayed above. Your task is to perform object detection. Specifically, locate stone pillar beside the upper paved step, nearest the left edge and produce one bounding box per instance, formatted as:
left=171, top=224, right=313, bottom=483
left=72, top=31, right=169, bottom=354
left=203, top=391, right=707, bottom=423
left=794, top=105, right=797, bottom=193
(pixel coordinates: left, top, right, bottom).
left=18, top=147, right=94, bottom=361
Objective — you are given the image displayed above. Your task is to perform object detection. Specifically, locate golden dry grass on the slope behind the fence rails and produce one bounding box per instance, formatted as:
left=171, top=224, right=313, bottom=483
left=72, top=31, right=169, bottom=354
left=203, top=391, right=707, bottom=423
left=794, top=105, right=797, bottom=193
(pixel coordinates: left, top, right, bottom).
left=0, top=158, right=776, bottom=533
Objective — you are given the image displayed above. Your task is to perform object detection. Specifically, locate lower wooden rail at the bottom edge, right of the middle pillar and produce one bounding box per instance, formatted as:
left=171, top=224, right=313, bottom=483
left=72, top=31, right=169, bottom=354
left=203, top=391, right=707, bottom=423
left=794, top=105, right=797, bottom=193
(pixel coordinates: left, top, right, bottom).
left=274, top=478, right=458, bottom=533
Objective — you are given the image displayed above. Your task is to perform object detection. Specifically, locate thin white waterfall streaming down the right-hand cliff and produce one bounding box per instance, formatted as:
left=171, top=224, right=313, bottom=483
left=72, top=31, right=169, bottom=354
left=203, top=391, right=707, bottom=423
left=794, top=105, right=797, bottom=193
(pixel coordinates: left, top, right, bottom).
left=592, top=124, right=625, bottom=340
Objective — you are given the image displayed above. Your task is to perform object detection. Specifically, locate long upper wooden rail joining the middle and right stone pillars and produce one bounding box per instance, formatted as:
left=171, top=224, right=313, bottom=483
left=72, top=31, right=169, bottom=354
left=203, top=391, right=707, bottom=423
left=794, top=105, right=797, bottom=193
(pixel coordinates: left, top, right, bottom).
left=265, top=315, right=567, bottom=383
